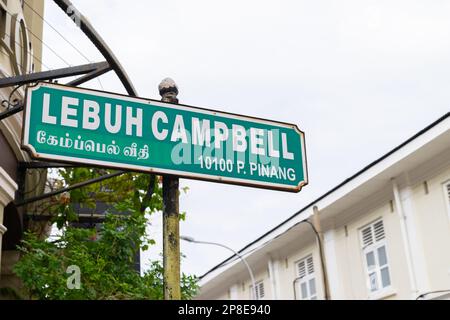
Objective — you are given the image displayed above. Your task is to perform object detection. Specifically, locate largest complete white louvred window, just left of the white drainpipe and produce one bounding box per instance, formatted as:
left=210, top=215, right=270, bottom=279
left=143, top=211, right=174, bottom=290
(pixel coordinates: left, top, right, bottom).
left=361, top=220, right=391, bottom=293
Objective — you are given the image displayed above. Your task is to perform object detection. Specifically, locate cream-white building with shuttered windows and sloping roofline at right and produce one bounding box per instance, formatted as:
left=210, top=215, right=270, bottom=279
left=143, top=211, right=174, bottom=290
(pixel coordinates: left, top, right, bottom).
left=197, top=113, right=450, bottom=299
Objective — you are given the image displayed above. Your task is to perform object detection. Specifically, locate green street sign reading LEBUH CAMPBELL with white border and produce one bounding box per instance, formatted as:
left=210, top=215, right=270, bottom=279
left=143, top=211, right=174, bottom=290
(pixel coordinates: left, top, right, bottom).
left=22, top=83, right=307, bottom=192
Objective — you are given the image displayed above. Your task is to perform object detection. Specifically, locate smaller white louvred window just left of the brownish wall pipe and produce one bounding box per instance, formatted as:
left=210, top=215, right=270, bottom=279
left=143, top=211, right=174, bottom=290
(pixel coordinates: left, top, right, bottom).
left=296, top=255, right=317, bottom=300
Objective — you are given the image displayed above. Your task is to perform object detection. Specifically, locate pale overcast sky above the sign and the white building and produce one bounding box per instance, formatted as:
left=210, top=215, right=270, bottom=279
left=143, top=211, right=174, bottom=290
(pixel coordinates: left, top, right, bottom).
left=39, top=0, right=450, bottom=275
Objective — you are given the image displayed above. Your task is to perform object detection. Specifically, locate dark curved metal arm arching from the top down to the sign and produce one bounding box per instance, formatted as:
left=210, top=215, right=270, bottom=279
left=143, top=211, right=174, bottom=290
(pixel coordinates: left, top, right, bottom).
left=54, top=0, right=137, bottom=96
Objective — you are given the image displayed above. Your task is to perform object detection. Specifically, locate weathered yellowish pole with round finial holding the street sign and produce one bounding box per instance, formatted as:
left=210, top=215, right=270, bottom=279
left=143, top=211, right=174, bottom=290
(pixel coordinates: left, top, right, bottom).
left=159, top=78, right=181, bottom=300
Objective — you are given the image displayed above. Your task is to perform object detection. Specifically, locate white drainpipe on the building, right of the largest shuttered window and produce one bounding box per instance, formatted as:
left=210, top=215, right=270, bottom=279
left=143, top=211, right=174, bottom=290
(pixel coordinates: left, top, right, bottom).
left=391, top=178, right=417, bottom=293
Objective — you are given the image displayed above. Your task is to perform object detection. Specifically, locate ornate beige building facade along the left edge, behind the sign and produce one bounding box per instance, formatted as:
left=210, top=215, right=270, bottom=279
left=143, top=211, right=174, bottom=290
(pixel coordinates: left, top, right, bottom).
left=0, top=0, right=45, bottom=296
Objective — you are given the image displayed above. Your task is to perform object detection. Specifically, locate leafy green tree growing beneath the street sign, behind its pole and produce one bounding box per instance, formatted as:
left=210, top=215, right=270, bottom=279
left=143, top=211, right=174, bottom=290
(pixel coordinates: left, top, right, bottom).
left=14, top=168, right=198, bottom=299
